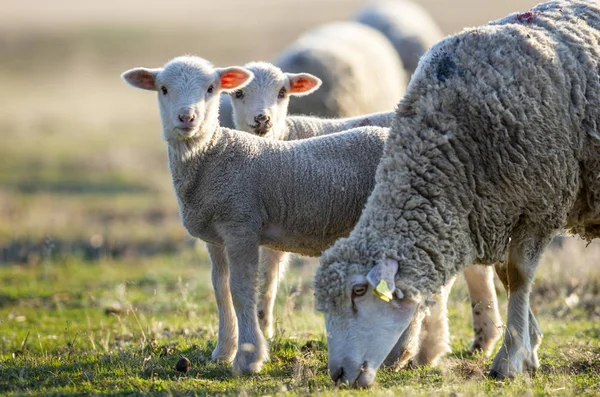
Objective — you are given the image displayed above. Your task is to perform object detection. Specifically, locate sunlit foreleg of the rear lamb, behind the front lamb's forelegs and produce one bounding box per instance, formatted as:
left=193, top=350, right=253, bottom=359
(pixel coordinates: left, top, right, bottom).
left=258, top=248, right=289, bottom=339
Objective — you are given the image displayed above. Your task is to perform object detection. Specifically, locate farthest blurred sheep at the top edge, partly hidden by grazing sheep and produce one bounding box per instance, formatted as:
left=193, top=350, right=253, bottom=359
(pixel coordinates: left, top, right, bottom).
left=354, top=0, right=444, bottom=76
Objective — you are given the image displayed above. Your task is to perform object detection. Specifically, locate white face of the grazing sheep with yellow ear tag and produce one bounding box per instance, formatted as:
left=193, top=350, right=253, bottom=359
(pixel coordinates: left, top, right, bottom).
left=318, top=259, right=418, bottom=387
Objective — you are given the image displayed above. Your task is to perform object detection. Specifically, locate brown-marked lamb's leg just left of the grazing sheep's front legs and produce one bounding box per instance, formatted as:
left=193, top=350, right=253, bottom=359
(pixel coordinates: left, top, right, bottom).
left=464, top=265, right=502, bottom=356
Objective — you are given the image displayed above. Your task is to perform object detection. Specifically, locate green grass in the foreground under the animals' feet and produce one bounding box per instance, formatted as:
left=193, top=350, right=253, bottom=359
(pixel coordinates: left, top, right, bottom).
left=0, top=252, right=600, bottom=396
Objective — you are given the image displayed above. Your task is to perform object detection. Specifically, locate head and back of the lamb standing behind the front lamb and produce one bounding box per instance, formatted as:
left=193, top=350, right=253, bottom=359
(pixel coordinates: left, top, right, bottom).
left=231, top=62, right=394, bottom=141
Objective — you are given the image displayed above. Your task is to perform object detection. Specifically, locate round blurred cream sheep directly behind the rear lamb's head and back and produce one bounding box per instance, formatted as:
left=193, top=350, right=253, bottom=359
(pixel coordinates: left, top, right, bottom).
left=274, top=22, right=408, bottom=117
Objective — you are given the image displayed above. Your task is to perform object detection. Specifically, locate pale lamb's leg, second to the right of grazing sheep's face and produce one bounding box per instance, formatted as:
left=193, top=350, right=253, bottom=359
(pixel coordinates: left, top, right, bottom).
left=413, top=277, right=456, bottom=365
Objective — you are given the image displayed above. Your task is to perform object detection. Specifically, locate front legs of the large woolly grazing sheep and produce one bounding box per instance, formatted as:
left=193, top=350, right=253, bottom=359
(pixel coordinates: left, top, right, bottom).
left=490, top=229, right=552, bottom=379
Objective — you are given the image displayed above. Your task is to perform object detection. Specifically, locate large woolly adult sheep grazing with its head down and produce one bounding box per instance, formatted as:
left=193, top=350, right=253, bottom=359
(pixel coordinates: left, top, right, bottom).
left=315, top=0, right=600, bottom=386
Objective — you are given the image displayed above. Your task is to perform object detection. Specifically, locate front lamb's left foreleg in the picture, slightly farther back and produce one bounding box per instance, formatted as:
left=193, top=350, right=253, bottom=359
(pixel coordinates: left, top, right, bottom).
left=206, top=244, right=238, bottom=363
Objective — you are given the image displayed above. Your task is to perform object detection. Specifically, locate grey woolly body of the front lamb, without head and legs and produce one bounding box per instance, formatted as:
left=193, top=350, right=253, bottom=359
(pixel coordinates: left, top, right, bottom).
left=169, top=127, right=387, bottom=256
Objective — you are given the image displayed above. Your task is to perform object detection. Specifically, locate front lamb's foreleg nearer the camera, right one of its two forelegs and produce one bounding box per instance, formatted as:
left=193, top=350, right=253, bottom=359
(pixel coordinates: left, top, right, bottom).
left=225, top=236, right=268, bottom=374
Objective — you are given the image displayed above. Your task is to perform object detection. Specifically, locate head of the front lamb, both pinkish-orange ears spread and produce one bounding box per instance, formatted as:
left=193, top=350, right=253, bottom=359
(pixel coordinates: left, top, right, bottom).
left=121, top=56, right=254, bottom=142
